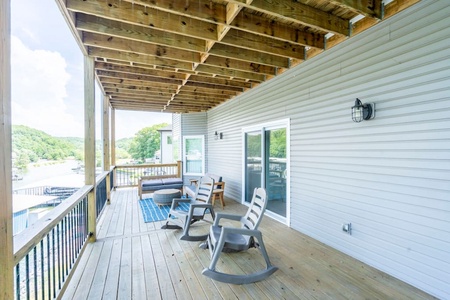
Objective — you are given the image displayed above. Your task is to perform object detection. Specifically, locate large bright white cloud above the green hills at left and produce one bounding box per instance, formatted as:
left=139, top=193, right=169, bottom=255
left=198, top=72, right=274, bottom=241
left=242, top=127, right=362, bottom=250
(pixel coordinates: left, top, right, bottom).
left=11, top=36, right=84, bottom=136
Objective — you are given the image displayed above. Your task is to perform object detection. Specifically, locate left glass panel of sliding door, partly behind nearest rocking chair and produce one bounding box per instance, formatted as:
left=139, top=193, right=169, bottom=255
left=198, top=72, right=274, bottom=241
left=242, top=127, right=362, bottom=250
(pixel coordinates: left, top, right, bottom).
left=245, top=131, right=262, bottom=203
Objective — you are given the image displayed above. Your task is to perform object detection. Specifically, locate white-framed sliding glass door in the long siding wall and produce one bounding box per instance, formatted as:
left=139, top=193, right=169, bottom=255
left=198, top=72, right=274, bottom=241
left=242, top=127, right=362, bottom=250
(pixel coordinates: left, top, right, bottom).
left=243, top=120, right=289, bottom=220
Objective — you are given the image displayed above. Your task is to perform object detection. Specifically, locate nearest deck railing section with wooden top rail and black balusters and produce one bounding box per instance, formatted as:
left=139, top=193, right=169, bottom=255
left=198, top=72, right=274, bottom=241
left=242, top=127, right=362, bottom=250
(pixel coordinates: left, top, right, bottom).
left=14, top=186, right=92, bottom=299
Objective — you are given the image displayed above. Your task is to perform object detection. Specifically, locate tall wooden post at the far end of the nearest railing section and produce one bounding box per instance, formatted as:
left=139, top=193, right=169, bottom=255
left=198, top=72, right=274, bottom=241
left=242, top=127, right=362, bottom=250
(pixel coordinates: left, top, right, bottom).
left=84, top=56, right=97, bottom=242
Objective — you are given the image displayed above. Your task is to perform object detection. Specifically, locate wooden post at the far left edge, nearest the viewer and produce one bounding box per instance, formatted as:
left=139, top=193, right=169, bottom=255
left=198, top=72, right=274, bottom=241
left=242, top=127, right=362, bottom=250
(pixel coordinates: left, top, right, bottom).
left=0, top=0, right=14, bottom=299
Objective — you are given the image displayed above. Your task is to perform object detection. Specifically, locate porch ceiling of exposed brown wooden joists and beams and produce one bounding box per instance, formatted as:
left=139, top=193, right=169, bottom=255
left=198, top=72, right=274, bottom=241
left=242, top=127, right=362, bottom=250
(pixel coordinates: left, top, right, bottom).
left=57, top=0, right=420, bottom=113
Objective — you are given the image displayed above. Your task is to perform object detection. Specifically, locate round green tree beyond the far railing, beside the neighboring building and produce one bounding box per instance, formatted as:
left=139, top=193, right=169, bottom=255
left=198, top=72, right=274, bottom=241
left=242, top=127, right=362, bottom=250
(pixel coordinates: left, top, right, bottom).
left=128, top=123, right=168, bottom=162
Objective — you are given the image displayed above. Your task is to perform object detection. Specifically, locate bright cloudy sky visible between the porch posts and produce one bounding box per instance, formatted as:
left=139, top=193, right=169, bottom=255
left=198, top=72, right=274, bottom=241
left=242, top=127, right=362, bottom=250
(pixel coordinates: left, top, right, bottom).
left=11, top=0, right=172, bottom=139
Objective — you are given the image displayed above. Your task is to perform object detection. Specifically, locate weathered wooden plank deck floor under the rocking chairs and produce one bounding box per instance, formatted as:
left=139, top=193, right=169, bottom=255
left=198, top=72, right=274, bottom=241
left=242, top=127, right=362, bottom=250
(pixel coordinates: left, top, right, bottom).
left=63, top=189, right=432, bottom=300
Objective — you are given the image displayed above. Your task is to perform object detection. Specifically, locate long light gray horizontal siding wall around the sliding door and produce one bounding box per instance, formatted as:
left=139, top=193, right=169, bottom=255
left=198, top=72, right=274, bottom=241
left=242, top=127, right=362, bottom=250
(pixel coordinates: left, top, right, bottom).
left=207, top=0, right=450, bottom=299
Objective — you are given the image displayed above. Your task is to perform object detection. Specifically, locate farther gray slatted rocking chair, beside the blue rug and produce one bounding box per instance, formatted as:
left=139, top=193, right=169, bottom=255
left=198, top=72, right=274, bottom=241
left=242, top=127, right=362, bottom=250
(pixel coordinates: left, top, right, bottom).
left=161, top=177, right=215, bottom=241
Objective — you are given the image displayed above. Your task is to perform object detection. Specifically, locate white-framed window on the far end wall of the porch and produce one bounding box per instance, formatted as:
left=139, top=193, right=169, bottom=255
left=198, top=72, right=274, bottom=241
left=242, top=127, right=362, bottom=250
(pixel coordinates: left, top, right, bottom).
left=183, top=135, right=205, bottom=176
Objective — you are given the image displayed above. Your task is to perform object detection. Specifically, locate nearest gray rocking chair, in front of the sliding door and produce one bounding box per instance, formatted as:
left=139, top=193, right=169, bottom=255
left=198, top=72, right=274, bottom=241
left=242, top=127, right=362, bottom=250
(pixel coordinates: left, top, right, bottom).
left=200, top=188, right=278, bottom=284
